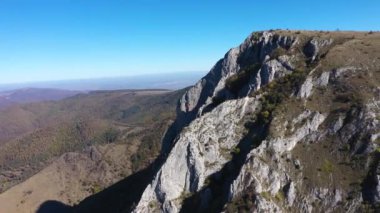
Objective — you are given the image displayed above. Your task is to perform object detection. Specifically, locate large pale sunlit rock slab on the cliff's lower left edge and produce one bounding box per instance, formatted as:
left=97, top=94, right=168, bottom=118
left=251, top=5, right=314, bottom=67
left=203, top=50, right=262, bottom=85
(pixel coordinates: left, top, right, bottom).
left=135, top=98, right=257, bottom=212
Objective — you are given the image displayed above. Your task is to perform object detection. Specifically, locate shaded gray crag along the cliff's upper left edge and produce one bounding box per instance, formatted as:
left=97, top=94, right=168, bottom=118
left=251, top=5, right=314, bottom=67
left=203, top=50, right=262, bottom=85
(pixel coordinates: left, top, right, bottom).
left=179, top=32, right=297, bottom=116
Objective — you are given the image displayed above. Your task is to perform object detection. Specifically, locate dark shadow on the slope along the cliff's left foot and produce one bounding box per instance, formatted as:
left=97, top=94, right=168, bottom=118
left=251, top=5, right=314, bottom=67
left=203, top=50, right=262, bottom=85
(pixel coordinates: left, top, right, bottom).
left=37, top=88, right=195, bottom=213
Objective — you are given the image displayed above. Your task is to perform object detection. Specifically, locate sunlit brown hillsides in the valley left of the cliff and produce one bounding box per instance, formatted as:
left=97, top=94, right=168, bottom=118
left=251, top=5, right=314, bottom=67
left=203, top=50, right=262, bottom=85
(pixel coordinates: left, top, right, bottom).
left=0, top=90, right=183, bottom=212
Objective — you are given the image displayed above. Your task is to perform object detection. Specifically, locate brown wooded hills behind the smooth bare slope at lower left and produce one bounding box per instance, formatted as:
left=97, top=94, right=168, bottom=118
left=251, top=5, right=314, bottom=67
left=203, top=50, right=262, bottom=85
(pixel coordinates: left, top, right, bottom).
left=0, top=88, right=182, bottom=191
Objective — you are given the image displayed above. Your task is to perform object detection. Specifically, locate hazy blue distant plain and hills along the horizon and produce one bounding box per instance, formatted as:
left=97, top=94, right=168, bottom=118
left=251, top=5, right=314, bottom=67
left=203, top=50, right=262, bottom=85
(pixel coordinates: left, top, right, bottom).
left=0, top=71, right=204, bottom=108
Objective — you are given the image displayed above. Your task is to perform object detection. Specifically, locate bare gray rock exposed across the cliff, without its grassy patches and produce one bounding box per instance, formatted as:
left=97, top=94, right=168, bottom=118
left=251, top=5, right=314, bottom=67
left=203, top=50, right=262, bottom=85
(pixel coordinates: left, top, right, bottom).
left=134, top=32, right=380, bottom=212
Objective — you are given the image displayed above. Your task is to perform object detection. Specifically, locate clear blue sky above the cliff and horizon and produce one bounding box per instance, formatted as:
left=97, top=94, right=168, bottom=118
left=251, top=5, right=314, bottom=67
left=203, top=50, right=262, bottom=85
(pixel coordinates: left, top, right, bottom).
left=0, top=0, right=380, bottom=83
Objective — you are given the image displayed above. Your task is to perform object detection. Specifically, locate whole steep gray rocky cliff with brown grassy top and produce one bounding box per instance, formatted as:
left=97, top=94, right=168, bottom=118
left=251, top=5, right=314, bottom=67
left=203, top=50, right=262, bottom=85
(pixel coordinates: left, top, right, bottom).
left=134, top=31, right=380, bottom=212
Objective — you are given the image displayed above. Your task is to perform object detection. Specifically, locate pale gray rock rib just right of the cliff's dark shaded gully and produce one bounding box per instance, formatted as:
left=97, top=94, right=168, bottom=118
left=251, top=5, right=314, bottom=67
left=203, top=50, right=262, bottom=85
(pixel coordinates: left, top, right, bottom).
left=229, top=111, right=326, bottom=212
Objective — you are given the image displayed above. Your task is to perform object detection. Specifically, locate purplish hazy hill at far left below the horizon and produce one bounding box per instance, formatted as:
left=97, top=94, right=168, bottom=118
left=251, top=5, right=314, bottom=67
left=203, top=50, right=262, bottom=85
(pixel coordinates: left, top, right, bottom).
left=0, top=88, right=82, bottom=108
